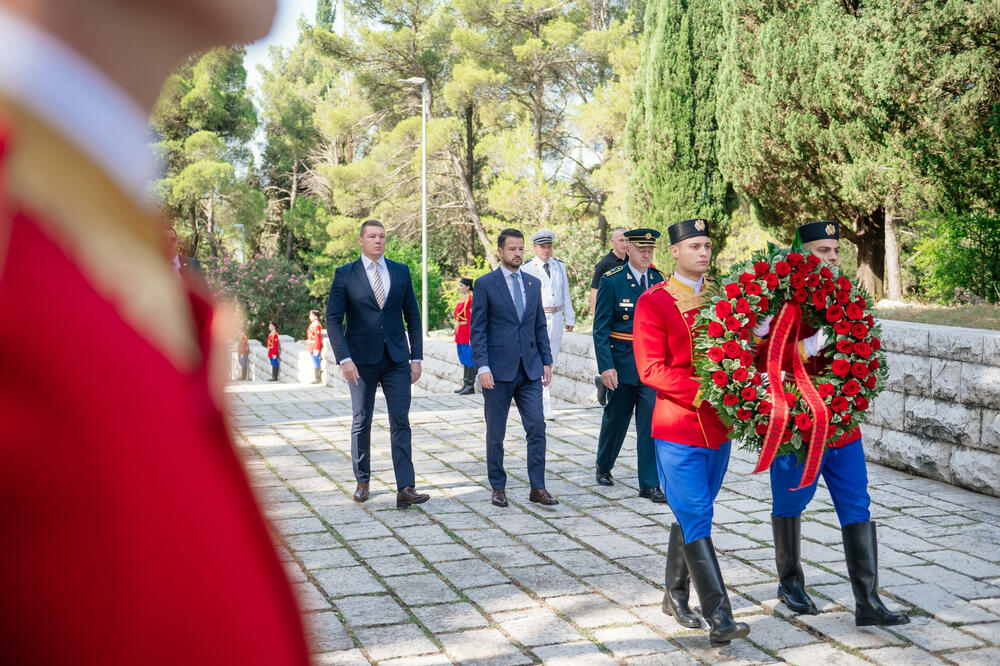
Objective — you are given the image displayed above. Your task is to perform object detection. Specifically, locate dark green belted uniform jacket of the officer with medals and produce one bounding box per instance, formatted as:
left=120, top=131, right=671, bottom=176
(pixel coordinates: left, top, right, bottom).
left=593, top=264, right=663, bottom=386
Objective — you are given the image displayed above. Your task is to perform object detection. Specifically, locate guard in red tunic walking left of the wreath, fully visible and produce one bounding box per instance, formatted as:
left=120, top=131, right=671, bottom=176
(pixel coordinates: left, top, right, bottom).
left=633, top=220, right=750, bottom=645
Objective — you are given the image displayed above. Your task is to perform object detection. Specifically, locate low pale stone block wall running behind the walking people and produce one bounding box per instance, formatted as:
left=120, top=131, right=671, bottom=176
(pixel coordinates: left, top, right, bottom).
left=233, top=320, right=1000, bottom=496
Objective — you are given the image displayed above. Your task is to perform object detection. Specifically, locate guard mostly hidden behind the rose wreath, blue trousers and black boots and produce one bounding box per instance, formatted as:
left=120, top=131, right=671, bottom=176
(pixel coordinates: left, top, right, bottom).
left=754, top=220, right=910, bottom=626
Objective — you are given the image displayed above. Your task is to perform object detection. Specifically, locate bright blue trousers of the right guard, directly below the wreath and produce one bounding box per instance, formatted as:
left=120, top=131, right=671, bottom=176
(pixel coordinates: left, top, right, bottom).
left=771, top=437, right=871, bottom=526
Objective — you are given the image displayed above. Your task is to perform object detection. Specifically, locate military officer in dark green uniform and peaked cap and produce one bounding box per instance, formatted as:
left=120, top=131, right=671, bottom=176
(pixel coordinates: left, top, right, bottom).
left=594, top=229, right=667, bottom=504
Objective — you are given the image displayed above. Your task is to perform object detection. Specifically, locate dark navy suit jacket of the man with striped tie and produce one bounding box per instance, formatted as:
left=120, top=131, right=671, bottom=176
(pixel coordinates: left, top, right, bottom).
left=326, top=259, right=424, bottom=365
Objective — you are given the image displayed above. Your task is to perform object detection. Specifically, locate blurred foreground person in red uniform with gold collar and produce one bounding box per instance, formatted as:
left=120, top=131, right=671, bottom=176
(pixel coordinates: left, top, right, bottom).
left=0, top=0, right=308, bottom=666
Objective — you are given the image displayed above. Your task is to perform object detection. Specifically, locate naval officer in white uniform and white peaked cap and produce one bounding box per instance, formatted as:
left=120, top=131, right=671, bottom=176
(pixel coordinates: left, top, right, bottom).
left=521, top=229, right=576, bottom=419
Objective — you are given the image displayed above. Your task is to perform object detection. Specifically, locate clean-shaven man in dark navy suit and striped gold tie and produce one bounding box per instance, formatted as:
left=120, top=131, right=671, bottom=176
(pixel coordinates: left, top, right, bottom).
left=326, top=220, right=428, bottom=508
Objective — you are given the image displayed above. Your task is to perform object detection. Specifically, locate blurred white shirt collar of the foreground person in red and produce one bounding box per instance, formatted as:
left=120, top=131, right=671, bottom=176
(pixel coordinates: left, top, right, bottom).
left=0, top=8, right=160, bottom=210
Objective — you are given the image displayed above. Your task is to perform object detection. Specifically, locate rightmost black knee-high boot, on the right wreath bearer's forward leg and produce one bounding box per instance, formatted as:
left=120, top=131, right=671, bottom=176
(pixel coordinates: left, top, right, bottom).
left=840, top=520, right=910, bottom=627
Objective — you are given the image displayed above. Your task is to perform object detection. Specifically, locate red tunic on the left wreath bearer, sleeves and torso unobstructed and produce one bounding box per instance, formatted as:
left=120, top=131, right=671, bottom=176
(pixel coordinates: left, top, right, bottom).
left=632, top=278, right=729, bottom=449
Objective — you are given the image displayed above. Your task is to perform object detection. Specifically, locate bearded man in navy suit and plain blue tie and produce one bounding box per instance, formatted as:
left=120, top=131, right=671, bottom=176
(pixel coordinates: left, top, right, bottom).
left=470, top=229, right=559, bottom=506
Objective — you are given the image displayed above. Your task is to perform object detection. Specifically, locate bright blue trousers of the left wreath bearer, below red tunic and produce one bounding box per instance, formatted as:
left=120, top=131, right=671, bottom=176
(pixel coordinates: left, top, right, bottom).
left=653, top=439, right=731, bottom=543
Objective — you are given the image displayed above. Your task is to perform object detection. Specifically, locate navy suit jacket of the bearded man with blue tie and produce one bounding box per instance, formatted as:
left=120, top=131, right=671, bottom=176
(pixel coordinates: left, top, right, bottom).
left=470, top=268, right=552, bottom=382
